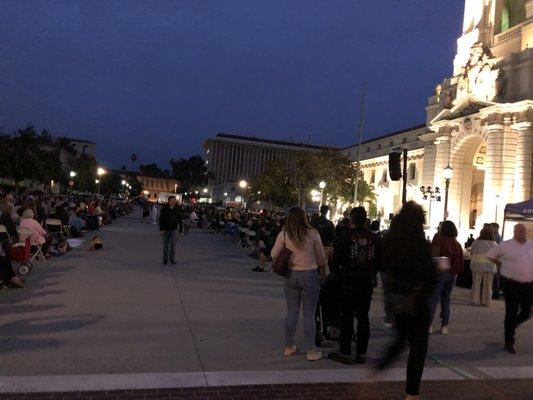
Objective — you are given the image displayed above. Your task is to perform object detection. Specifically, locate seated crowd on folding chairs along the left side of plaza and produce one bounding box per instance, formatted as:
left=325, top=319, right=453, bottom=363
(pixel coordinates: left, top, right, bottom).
left=0, top=192, right=132, bottom=290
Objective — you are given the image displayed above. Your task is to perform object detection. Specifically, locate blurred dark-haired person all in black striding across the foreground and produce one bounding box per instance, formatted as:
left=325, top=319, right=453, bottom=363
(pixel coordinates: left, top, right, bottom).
left=378, top=201, right=437, bottom=400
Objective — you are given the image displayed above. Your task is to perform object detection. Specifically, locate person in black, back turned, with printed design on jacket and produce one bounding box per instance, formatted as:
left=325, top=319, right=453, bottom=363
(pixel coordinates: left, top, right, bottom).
left=329, top=207, right=381, bottom=365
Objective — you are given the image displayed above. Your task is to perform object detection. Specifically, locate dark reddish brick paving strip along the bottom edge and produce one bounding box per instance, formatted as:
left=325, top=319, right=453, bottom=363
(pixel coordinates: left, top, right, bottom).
left=0, top=380, right=533, bottom=400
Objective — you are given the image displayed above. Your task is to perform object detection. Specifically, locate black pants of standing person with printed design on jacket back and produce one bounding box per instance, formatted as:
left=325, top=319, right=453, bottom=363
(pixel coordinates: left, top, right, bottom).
left=340, top=277, right=374, bottom=356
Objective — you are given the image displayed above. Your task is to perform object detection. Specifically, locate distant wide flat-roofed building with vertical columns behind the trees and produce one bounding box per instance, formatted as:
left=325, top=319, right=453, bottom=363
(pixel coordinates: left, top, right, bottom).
left=204, top=133, right=338, bottom=201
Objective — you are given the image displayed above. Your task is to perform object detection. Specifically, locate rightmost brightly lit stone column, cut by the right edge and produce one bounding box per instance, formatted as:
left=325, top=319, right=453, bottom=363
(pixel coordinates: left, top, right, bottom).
left=513, top=121, right=533, bottom=203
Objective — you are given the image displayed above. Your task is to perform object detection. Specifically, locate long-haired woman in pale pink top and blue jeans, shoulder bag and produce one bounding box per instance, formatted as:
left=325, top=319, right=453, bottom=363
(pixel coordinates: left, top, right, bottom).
left=270, top=207, right=326, bottom=361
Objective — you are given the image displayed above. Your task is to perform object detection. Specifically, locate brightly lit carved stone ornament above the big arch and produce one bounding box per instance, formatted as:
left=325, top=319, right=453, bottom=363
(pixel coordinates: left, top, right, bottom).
left=454, top=42, right=501, bottom=105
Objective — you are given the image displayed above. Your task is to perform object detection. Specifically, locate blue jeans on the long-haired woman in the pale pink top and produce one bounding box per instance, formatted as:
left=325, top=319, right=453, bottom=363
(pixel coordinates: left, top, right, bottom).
left=285, top=269, right=320, bottom=350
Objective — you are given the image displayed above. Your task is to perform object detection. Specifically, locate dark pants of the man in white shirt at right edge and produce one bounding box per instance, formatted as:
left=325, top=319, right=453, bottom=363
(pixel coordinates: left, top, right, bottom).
left=501, top=276, right=533, bottom=343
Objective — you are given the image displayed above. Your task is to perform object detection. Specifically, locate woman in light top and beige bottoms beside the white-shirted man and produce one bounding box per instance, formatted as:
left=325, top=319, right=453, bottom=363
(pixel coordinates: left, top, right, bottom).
left=470, top=228, right=497, bottom=307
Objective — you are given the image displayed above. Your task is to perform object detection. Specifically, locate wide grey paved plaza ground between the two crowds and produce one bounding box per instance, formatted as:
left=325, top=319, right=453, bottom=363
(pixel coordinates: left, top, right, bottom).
left=0, top=212, right=533, bottom=399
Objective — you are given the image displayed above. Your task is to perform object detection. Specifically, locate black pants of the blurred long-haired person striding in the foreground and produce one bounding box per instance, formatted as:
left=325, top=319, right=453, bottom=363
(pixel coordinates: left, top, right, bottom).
left=379, top=306, right=429, bottom=396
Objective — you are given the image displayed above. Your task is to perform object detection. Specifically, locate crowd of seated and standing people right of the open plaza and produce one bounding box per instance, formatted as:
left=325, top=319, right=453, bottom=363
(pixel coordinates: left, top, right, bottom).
left=182, top=202, right=533, bottom=399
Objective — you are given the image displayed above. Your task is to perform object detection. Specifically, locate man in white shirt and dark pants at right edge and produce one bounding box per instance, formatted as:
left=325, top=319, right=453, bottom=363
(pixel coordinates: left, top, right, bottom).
left=487, top=224, right=533, bottom=354
